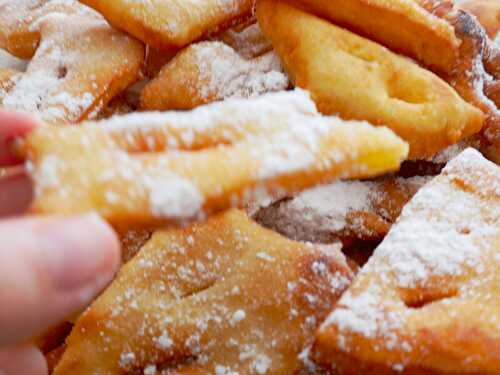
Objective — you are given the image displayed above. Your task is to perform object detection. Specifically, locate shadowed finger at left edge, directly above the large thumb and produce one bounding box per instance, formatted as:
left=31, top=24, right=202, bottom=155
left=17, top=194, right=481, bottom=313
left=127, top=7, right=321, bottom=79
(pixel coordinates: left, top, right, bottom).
left=0, top=167, right=33, bottom=217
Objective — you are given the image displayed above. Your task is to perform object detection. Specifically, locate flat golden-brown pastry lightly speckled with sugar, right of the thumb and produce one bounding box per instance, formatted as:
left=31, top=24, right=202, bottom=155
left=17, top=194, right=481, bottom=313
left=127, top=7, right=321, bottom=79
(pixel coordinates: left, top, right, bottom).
left=55, top=210, right=353, bottom=375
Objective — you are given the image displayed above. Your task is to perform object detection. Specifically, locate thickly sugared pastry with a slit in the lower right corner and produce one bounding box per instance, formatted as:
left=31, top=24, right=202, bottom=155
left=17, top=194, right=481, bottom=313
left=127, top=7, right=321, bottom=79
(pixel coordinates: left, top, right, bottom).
left=311, top=149, right=500, bottom=375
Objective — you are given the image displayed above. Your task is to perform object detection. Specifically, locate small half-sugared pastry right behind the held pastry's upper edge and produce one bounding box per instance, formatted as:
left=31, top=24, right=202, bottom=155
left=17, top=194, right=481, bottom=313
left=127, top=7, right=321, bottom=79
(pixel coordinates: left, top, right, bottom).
left=141, top=42, right=289, bottom=110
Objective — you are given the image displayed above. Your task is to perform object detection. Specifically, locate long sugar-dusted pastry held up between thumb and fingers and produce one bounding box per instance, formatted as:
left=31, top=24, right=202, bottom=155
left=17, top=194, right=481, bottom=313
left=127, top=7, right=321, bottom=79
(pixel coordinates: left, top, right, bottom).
left=20, top=90, right=408, bottom=225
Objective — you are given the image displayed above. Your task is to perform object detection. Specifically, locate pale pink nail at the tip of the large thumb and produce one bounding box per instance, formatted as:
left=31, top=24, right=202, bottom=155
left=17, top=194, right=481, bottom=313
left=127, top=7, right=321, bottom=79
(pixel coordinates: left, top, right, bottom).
left=40, top=214, right=120, bottom=293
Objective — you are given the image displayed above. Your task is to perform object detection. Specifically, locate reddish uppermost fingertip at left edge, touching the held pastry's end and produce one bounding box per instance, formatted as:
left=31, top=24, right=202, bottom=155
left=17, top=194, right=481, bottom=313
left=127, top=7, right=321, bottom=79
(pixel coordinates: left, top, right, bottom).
left=0, top=109, right=37, bottom=165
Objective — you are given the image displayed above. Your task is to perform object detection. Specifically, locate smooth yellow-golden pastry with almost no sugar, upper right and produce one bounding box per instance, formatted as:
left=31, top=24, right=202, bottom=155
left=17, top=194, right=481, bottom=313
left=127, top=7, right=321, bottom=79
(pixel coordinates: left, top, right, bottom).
left=257, top=0, right=483, bottom=159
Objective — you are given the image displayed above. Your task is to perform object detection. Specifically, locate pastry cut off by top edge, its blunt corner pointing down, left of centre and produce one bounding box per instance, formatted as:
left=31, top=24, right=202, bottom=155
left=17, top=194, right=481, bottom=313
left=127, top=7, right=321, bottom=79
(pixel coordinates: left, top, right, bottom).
left=81, top=0, right=254, bottom=49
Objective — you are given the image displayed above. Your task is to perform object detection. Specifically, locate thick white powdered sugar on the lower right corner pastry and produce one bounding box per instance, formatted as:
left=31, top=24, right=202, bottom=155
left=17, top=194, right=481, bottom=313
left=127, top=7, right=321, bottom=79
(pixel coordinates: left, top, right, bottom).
left=321, top=149, right=500, bottom=356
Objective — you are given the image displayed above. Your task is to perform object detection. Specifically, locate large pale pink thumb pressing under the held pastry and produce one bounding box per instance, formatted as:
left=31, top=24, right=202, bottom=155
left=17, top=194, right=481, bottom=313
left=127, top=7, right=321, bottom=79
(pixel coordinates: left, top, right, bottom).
left=0, top=214, right=120, bottom=347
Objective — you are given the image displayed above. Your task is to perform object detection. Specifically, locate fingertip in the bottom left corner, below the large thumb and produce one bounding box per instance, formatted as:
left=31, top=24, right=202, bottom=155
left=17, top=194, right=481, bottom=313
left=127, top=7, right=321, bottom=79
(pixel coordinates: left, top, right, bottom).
left=0, top=345, right=48, bottom=375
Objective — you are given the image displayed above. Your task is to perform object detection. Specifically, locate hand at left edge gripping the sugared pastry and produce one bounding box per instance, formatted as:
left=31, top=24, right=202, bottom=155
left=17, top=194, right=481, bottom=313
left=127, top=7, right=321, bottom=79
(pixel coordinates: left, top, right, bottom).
left=0, top=110, right=120, bottom=375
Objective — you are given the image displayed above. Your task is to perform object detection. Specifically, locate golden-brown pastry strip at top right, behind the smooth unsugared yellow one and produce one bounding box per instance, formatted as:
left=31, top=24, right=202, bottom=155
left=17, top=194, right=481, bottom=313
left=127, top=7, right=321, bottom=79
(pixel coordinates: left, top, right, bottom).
left=280, top=0, right=460, bottom=72
